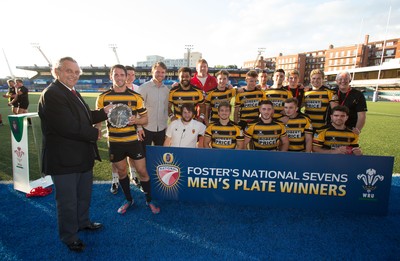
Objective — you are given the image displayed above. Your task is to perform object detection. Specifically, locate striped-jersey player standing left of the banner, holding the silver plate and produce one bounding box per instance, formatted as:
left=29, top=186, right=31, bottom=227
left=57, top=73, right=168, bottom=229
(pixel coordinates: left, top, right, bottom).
left=97, top=64, right=160, bottom=214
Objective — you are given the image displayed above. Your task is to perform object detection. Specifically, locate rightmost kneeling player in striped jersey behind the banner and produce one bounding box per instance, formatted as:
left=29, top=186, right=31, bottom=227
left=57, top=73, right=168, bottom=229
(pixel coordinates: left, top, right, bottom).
left=313, top=105, right=362, bottom=155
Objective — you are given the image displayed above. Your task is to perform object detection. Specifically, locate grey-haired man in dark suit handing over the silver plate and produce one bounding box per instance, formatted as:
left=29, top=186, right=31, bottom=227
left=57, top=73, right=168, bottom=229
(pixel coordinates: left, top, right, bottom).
left=38, top=57, right=111, bottom=252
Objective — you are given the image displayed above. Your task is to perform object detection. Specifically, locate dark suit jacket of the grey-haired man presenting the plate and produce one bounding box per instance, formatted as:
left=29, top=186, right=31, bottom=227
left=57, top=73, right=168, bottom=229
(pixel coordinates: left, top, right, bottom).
left=38, top=80, right=107, bottom=175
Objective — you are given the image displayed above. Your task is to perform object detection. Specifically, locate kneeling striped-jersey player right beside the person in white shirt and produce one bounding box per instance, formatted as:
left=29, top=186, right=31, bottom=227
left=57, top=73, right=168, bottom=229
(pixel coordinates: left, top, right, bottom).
left=204, top=102, right=244, bottom=150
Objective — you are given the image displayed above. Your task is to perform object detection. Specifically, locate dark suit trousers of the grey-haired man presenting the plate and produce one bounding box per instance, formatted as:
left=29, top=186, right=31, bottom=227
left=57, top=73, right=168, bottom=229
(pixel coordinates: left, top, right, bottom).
left=51, top=170, right=93, bottom=244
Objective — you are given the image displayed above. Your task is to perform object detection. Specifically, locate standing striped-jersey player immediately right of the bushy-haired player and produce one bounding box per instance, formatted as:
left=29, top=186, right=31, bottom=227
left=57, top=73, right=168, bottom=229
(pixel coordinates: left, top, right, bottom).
left=205, top=70, right=236, bottom=126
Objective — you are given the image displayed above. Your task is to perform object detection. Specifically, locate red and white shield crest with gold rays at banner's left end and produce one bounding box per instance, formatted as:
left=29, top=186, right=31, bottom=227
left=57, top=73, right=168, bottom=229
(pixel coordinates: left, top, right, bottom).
left=156, top=152, right=181, bottom=198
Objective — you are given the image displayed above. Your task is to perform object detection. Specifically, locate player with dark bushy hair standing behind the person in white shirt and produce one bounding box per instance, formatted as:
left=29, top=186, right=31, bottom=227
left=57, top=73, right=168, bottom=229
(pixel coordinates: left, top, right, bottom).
left=168, top=67, right=205, bottom=122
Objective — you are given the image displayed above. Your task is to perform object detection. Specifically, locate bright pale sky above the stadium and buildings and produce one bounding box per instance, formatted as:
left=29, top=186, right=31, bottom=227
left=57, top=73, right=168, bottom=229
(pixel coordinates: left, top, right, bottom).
left=0, top=0, right=400, bottom=77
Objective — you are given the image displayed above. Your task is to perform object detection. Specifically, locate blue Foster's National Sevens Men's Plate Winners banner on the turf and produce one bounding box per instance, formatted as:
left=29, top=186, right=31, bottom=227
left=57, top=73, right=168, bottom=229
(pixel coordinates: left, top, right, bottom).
left=146, top=146, right=394, bottom=215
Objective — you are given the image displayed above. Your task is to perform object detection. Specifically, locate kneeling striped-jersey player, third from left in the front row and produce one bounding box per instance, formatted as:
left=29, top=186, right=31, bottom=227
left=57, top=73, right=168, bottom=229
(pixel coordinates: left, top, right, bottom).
left=244, top=100, right=289, bottom=151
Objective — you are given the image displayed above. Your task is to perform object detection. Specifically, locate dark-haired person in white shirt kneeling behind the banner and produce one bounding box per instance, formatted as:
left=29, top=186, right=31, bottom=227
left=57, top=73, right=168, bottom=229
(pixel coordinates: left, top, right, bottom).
left=164, top=103, right=206, bottom=148
